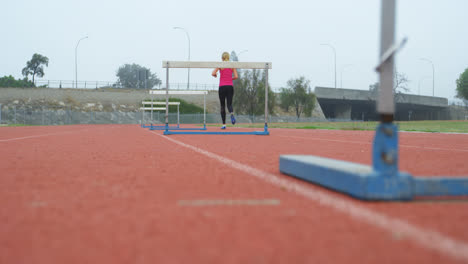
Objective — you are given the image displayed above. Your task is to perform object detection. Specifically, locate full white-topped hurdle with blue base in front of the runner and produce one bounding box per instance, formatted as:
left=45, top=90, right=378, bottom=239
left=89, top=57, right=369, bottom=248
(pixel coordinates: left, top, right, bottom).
left=158, top=61, right=272, bottom=135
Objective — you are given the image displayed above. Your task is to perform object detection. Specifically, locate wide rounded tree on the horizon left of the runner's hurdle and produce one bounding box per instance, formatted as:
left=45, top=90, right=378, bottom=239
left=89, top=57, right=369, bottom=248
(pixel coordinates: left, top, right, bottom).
left=116, top=63, right=161, bottom=89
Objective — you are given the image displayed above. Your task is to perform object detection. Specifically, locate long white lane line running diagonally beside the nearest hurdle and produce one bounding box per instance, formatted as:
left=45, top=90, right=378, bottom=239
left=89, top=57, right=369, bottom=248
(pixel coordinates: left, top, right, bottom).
left=150, top=131, right=468, bottom=261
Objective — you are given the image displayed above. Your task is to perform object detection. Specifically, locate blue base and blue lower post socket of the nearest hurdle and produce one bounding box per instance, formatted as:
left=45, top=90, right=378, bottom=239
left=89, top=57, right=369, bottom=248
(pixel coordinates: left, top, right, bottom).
left=280, top=123, right=468, bottom=201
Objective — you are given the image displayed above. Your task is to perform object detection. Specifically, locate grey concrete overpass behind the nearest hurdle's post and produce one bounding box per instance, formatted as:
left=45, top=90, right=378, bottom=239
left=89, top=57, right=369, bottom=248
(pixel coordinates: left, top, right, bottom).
left=315, top=87, right=448, bottom=121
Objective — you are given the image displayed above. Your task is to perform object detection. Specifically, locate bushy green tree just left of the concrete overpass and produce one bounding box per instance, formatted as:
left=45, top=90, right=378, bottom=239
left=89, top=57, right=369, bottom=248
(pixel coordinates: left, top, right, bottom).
left=280, top=77, right=315, bottom=118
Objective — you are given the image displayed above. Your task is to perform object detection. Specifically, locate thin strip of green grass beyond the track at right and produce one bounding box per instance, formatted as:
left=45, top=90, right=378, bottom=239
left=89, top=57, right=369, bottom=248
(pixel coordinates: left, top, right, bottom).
left=230, top=121, right=468, bottom=133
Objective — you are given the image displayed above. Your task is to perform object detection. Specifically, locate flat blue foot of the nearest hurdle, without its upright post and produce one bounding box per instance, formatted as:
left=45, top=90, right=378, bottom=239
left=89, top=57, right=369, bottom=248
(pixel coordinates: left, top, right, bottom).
left=279, top=155, right=468, bottom=201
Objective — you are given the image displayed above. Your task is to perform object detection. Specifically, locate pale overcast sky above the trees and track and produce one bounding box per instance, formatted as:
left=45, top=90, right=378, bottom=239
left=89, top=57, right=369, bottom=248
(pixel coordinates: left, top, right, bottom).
left=0, top=0, right=468, bottom=100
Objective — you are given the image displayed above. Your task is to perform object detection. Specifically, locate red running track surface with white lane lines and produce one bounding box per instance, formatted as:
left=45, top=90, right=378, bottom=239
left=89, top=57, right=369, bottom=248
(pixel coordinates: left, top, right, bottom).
left=0, top=125, right=468, bottom=263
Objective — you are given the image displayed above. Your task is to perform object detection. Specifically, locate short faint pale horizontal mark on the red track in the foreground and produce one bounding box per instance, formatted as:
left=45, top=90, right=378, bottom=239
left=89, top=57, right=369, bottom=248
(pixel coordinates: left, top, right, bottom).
left=178, top=199, right=280, bottom=207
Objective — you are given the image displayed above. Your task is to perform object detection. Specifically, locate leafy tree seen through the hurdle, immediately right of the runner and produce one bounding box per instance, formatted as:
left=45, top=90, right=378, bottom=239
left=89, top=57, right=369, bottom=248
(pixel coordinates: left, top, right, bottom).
left=233, top=69, right=275, bottom=116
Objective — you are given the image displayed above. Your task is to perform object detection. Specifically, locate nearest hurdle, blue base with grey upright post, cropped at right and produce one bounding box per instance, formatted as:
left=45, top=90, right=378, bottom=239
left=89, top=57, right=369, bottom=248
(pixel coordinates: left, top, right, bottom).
left=279, top=0, right=468, bottom=201
